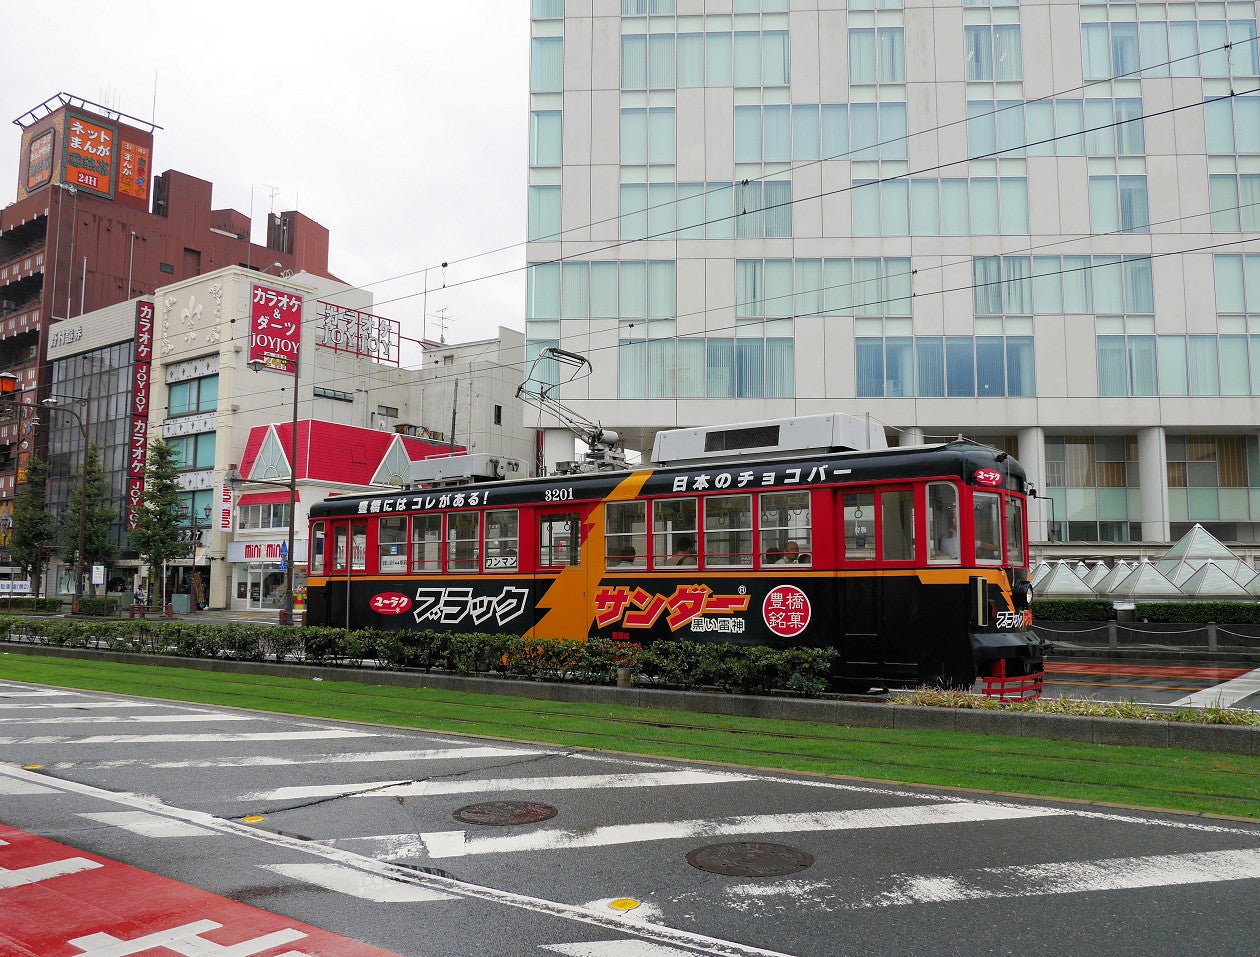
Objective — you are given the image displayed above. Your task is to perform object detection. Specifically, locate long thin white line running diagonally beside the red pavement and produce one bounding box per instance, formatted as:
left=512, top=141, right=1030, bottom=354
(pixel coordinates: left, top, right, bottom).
left=0, top=764, right=790, bottom=957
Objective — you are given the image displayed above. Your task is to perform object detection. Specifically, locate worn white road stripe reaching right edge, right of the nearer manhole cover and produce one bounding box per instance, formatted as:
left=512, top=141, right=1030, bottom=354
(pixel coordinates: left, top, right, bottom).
left=853, top=847, right=1260, bottom=907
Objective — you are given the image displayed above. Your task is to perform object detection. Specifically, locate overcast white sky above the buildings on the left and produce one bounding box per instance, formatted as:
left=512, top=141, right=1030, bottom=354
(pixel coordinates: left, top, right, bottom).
left=0, top=0, right=529, bottom=357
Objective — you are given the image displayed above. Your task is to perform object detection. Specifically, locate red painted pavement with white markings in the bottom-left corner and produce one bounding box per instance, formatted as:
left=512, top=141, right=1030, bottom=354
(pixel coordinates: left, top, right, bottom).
left=0, top=824, right=397, bottom=957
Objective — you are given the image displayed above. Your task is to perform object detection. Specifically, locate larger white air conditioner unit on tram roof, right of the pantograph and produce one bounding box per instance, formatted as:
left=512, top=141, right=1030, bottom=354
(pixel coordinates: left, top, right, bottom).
left=651, top=412, right=888, bottom=465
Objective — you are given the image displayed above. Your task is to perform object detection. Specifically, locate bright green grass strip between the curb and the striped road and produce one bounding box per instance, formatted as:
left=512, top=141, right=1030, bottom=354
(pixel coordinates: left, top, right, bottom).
left=0, top=652, right=1260, bottom=818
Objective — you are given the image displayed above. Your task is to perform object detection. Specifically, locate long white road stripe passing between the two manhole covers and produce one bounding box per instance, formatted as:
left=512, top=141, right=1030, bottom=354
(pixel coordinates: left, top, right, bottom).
left=420, top=801, right=1066, bottom=859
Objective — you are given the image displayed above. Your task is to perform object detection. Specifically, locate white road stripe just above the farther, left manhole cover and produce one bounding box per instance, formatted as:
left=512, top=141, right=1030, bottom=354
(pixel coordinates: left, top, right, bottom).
left=241, top=771, right=752, bottom=801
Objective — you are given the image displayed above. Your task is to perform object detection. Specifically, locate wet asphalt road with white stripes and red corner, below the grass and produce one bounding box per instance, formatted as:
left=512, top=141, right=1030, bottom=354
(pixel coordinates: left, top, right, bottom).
left=0, top=682, right=1260, bottom=957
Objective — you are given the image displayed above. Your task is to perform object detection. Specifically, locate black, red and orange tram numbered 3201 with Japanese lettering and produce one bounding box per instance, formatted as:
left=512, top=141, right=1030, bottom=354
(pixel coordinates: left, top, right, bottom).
left=306, top=416, right=1046, bottom=696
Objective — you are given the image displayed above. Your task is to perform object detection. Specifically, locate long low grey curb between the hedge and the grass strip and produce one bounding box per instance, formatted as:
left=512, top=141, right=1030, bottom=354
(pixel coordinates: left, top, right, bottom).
left=0, top=642, right=1260, bottom=756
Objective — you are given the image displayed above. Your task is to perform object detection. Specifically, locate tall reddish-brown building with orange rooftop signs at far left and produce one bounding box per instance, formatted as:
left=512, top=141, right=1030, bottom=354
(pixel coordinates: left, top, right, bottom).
left=0, top=93, right=333, bottom=508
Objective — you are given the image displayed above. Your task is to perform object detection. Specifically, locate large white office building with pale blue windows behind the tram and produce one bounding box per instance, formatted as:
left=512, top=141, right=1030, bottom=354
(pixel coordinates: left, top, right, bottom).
left=527, top=0, right=1260, bottom=552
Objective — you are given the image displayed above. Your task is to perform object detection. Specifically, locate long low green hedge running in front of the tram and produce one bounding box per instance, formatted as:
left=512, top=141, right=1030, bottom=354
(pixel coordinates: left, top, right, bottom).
left=0, top=616, right=835, bottom=695
